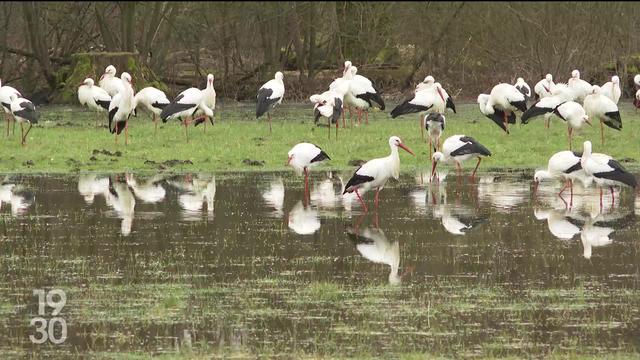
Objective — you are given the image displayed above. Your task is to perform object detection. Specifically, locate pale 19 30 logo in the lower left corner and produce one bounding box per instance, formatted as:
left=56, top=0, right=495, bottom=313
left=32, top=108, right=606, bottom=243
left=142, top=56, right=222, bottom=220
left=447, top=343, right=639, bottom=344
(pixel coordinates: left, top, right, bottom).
left=29, top=289, right=67, bottom=345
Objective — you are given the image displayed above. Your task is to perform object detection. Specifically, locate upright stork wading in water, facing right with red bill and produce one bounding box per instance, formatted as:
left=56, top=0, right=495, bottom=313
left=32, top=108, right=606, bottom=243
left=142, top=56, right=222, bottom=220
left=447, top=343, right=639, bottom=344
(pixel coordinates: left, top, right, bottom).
left=342, top=136, right=415, bottom=213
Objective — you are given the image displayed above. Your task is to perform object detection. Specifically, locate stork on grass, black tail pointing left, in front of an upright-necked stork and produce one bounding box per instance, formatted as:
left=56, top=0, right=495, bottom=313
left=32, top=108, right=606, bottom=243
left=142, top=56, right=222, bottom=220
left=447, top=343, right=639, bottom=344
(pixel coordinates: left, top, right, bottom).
left=160, top=88, right=213, bottom=142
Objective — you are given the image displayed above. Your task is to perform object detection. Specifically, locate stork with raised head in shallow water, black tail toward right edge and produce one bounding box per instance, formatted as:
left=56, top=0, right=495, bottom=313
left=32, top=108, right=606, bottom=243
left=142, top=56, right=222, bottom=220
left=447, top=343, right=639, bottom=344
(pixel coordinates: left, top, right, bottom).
left=580, top=141, right=637, bottom=209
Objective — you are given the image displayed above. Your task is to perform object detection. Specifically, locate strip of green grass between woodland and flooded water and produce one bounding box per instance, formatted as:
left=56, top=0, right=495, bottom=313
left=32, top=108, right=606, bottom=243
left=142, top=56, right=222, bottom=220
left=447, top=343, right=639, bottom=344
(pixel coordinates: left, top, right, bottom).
left=0, top=99, right=640, bottom=173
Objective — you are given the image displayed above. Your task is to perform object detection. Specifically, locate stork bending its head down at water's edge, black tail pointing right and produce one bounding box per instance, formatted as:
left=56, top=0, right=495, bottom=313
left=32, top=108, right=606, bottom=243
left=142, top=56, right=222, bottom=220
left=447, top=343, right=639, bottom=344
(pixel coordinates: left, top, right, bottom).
left=431, top=135, right=491, bottom=178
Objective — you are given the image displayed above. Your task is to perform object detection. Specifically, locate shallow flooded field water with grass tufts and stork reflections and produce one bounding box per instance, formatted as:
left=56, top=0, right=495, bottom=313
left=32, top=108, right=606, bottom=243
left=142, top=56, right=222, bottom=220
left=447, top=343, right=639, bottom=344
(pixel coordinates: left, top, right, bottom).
left=0, top=169, right=640, bottom=358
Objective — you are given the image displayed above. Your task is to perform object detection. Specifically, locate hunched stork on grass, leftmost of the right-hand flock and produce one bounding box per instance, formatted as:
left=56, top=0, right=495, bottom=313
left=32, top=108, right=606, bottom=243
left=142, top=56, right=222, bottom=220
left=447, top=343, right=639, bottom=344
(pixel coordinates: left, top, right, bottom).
left=478, top=83, right=527, bottom=134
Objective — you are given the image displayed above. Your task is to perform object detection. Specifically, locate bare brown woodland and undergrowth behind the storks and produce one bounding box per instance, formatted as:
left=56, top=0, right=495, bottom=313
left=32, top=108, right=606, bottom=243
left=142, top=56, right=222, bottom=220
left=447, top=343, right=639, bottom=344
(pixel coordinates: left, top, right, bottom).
left=0, top=2, right=640, bottom=102
